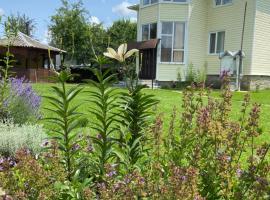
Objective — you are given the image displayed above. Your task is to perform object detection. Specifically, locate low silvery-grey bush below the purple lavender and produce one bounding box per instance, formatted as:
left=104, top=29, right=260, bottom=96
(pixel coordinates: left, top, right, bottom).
left=0, top=121, right=46, bottom=156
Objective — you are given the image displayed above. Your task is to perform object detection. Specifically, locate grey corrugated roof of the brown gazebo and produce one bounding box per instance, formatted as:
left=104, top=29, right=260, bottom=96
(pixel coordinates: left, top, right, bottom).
left=0, top=32, right=66, bottom=53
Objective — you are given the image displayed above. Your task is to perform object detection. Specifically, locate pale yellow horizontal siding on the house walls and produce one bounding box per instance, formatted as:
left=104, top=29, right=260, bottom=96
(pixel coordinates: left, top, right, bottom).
left=138, top=0, right=258, bottom=81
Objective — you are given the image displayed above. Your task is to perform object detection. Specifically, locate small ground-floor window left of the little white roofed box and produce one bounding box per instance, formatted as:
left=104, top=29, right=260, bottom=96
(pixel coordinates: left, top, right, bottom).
left=209, top=31, right=225, bottom=54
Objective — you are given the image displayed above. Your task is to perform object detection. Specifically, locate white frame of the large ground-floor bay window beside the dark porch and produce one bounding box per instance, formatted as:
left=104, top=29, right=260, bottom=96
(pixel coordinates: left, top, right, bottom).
left=159, top=21, right=187, bottom=65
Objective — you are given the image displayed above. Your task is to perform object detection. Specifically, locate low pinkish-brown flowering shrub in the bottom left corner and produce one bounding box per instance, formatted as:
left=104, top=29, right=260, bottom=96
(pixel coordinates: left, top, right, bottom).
left=0, top=146, right=64, bottom=200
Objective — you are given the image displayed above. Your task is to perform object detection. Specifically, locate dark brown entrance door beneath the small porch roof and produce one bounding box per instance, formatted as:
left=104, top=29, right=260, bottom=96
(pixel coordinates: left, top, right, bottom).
left=139, top=49, right=157, bottom=80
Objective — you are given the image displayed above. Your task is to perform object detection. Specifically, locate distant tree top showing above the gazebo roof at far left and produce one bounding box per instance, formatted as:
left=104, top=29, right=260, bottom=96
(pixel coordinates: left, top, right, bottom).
left=5, top=13, right=36, bottom=36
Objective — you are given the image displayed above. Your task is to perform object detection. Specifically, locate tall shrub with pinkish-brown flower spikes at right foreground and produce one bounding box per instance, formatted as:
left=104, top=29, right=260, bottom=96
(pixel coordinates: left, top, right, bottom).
left=167, top=76, right=270, bottom=199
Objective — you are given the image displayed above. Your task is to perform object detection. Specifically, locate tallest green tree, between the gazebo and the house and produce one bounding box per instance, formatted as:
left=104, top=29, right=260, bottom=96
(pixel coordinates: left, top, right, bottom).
left=49, top=0, right=89, bottom=63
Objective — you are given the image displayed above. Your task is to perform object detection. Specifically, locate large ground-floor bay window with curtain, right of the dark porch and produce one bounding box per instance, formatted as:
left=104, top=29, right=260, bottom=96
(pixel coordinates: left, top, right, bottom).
left=161, top=22, right=185, bottom=63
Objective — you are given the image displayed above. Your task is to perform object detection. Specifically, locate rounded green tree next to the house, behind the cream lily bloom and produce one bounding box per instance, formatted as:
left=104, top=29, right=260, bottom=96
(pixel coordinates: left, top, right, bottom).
left=108, top=19, right=137, bottom=48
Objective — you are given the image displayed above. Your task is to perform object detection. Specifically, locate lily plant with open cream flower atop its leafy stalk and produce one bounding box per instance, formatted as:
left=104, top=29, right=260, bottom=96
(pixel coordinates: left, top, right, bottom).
left=104, top=44, right=158, bottom=165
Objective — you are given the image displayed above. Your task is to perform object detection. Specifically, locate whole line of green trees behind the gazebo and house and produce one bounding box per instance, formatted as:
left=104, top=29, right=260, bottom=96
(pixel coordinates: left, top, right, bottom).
left=2, top=0, right=137, bottom=64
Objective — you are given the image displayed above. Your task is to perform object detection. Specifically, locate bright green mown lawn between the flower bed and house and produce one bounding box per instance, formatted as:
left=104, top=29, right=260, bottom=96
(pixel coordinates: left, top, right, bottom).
left=33, top=83, right=270, bottom=145
